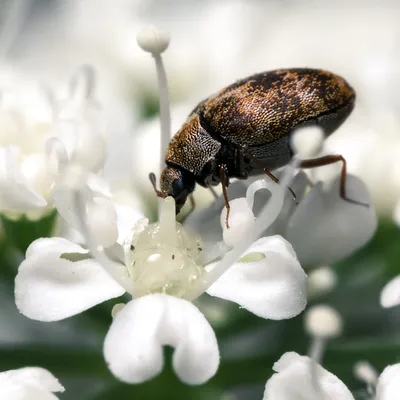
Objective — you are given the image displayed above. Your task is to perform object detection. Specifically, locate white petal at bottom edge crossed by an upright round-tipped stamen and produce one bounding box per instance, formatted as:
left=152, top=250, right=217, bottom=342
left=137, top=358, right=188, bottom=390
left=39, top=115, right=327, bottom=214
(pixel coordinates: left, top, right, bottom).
left=263, top=352, right=354, bottom=400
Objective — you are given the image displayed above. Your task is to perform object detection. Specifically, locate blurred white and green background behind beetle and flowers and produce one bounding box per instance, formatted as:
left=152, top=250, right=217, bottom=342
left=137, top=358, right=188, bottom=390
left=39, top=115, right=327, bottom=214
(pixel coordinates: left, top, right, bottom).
left=0, top=0, right=400, bottom=400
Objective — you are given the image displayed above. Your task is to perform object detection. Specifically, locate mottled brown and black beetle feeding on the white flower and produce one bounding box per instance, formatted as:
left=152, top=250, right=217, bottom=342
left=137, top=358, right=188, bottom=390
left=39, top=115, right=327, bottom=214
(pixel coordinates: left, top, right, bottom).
left=151, top=68, right=361, bottom=227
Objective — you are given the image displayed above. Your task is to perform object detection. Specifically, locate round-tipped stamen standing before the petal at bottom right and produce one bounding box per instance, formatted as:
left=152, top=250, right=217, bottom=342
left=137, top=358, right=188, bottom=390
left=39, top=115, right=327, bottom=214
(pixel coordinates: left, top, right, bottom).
left=305, top=305, right=343, bottom=400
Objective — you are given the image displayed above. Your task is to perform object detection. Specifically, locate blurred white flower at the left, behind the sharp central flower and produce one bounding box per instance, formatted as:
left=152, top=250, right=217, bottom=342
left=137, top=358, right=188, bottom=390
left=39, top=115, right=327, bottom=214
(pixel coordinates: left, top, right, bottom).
left=0, top=68, right=105, bottom=218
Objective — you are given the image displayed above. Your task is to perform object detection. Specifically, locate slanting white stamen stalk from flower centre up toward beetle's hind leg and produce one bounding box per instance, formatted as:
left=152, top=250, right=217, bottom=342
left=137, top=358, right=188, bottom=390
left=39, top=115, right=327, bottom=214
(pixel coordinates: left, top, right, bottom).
left=189, top=157, right=300, bottom=300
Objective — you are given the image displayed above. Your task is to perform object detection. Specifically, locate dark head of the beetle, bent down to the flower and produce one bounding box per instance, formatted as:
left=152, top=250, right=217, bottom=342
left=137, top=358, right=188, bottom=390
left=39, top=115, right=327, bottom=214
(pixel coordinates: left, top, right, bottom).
left=160, top=167, right=195, bottom=214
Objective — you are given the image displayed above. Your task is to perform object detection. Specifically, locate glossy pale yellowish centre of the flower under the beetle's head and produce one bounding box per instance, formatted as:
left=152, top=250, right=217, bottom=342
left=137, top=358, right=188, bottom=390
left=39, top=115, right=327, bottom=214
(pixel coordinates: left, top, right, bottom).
left=127, top=198, right=206, bottom=298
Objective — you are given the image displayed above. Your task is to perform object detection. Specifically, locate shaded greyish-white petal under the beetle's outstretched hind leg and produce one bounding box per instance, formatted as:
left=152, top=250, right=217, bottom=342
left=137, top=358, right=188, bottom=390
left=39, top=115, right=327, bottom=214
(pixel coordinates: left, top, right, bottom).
left=284, top=175, right=377, bottom=265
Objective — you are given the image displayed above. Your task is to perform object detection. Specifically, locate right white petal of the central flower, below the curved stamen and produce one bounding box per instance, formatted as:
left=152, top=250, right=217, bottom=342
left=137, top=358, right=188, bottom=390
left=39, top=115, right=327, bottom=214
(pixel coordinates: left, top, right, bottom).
left=207, top=236, right=307, bottom=320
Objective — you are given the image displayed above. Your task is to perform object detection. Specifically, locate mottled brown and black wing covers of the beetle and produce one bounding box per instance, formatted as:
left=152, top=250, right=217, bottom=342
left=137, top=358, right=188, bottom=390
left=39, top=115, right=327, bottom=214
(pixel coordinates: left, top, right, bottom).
left=194, top=68, right=355, bottom=146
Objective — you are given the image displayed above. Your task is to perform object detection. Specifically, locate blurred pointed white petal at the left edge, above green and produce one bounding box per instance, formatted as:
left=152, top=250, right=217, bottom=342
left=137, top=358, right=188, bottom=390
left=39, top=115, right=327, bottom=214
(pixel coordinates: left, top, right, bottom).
left=0, top=145, right=47, bottom=211
